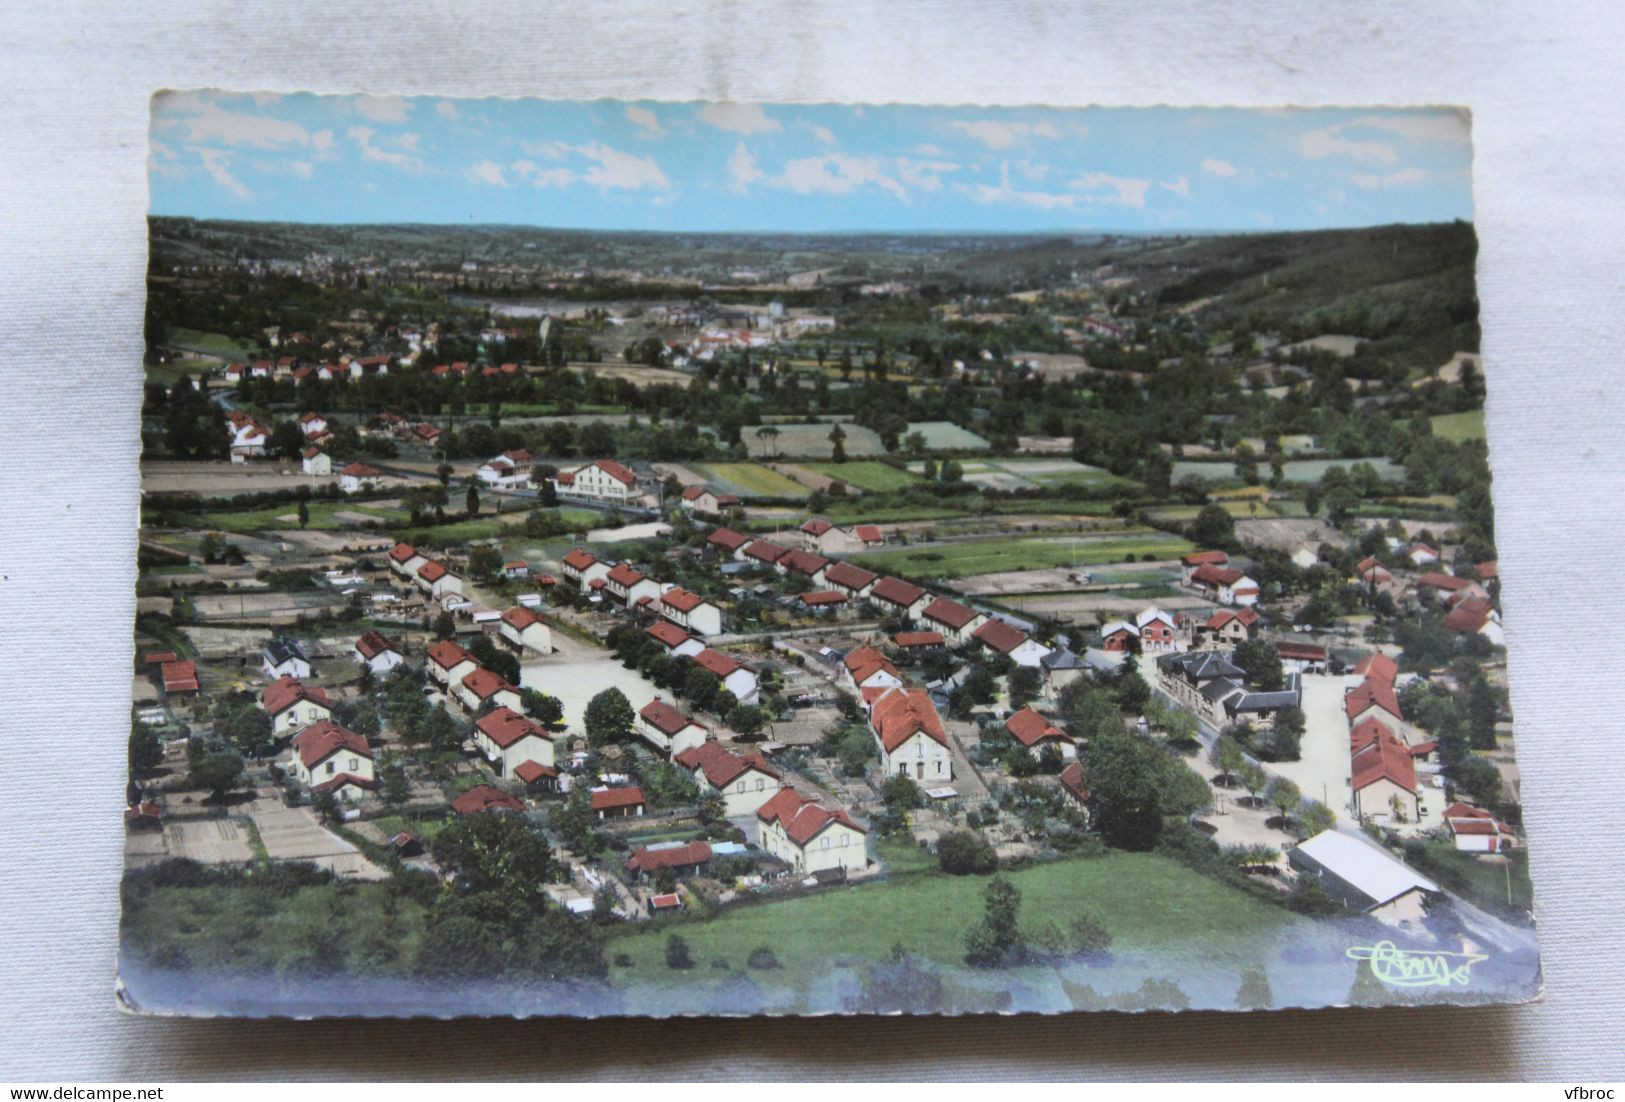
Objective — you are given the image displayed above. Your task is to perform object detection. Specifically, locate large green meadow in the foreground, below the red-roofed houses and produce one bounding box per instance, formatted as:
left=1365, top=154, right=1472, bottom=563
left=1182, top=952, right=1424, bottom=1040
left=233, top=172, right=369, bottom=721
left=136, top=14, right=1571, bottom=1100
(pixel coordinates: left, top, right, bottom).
left=609, top=852, right=1305, bottom=987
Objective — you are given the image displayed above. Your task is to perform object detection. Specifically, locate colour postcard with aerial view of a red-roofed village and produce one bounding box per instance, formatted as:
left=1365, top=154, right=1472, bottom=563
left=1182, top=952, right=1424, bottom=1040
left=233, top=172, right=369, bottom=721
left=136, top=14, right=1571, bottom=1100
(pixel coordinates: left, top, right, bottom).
left=119, top=91, right=1541, bottom=1017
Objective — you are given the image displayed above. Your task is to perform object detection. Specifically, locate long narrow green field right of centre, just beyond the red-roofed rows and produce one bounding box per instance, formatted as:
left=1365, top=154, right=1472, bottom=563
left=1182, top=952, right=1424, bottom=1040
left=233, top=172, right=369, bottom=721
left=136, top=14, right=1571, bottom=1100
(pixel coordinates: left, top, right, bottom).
left=856, top=533, right=1194, bottom=577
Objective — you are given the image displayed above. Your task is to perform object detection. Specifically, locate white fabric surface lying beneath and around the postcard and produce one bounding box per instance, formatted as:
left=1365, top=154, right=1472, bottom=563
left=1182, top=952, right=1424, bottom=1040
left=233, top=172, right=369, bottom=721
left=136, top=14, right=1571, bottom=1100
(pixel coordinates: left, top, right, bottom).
left=0, top=0, right=1625, bottom=1081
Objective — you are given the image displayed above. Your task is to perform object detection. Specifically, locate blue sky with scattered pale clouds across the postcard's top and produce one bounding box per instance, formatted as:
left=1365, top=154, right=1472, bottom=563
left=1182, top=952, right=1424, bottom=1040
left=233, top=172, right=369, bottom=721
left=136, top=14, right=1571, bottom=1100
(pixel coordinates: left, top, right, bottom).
left=148, top=91, right=1472, bottom=232
